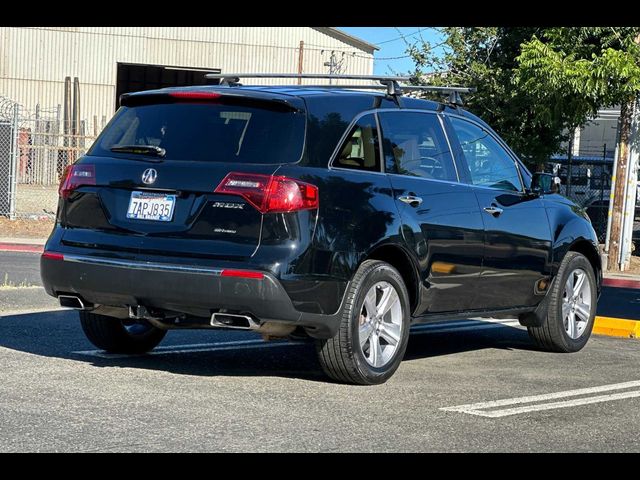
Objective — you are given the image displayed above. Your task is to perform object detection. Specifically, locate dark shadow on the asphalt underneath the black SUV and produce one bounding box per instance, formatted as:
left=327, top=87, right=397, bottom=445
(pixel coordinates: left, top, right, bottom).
left=0, top=311, right=533, bottom=382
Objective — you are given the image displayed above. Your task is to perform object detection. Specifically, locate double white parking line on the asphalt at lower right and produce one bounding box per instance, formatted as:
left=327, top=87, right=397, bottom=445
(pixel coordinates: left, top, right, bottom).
left=440, top=380, right=640, bottom=418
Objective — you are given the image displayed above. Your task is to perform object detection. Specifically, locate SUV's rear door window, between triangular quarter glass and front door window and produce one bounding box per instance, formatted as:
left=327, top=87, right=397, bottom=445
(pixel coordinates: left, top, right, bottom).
left=380, top=112, right=458, bottom=182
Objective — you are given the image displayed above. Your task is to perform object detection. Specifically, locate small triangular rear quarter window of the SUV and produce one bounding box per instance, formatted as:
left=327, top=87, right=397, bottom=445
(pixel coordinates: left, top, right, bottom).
left=333, top=114, right=381, bottom=172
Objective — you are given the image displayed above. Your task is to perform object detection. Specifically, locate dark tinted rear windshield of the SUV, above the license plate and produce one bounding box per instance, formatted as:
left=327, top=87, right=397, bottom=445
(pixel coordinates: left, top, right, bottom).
left=88, top=103, right=305, bottom=164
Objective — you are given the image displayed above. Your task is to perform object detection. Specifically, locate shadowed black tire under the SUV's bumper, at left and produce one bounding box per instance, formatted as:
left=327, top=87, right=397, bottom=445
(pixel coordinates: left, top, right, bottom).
left=79, top=311, right=167, bottom=353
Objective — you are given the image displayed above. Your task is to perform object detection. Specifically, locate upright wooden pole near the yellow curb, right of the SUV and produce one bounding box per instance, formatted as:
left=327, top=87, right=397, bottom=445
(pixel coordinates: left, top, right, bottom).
left=607, top=35, right=640, bottom=272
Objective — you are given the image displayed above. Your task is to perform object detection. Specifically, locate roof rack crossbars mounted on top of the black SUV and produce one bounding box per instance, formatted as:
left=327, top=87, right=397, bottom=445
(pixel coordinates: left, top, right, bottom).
left=205, top=73, right=476, bottom=105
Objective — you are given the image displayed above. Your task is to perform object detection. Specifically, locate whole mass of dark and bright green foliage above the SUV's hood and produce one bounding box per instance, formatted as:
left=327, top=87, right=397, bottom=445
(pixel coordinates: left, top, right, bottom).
left=409, top=27, right=640, bottom=169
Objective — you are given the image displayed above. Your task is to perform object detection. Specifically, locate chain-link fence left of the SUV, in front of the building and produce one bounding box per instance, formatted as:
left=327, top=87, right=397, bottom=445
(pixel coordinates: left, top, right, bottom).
left=0, top=97, right=97, bottom=219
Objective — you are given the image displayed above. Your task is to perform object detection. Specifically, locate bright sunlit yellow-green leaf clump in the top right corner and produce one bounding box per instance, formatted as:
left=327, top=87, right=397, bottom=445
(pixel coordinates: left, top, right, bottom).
left=514, top=27, right=640, bottom=113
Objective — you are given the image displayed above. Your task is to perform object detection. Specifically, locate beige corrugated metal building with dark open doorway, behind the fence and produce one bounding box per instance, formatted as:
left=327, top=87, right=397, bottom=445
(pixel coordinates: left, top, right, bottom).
left=0, top=27, right=376, bottom=218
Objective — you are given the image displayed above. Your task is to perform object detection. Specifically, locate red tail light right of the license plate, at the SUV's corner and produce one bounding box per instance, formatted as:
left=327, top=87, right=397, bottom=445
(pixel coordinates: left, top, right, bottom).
left=215, top=172, right=319, bottom=213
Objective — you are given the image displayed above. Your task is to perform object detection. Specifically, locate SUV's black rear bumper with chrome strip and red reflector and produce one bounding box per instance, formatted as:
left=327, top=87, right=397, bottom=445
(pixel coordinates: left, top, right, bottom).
left=40, top=253, right=342, bottom=338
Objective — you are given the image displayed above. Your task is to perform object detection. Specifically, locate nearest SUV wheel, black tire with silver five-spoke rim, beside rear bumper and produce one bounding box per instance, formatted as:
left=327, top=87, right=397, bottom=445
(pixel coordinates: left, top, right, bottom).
left=316, top=260, right=410, bottom=385
